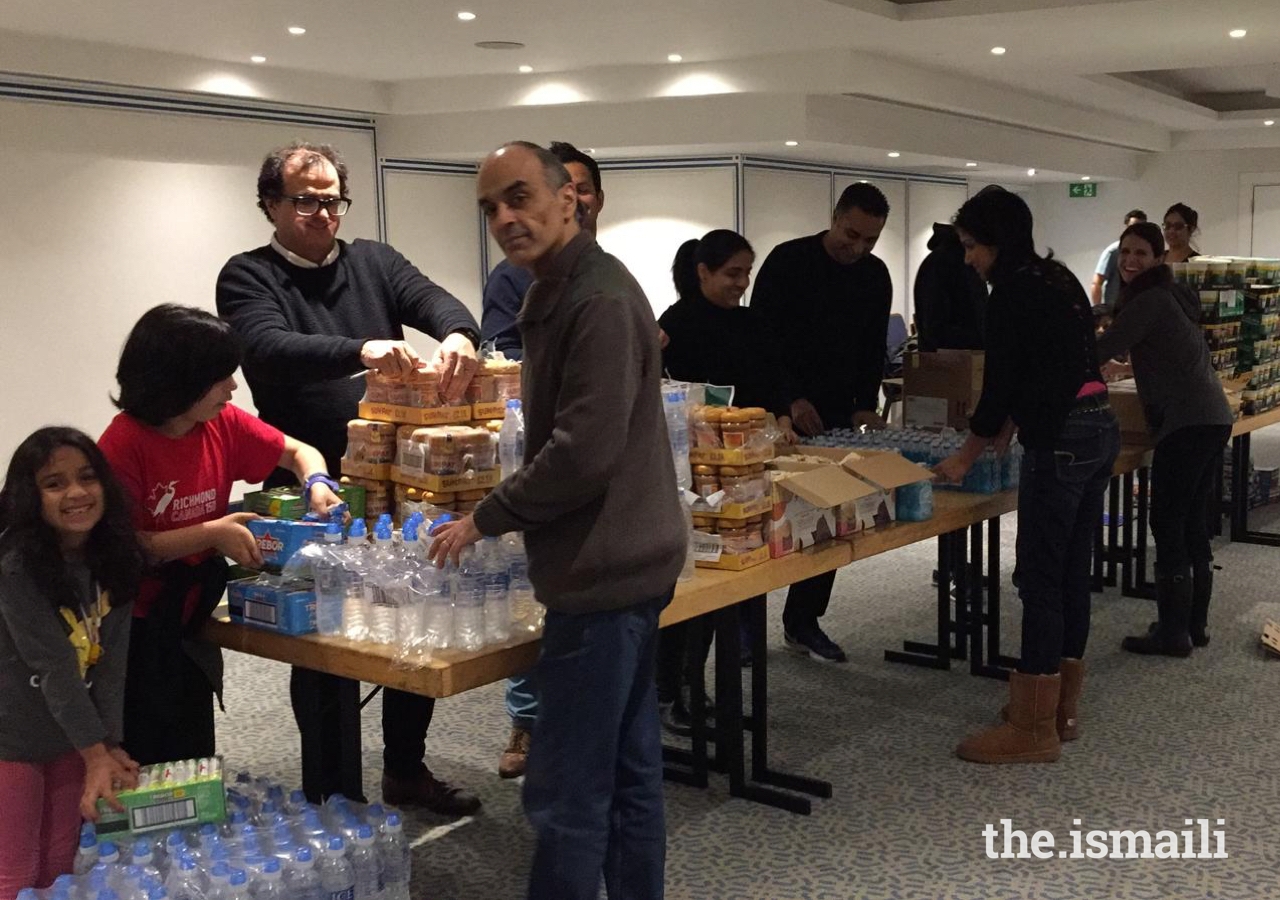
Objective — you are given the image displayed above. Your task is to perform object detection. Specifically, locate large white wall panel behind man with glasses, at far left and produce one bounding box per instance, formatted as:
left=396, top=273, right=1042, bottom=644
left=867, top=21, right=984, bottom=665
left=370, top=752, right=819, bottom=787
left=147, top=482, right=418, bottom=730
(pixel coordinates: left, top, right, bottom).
left=0, top=90, right=378, bottom=462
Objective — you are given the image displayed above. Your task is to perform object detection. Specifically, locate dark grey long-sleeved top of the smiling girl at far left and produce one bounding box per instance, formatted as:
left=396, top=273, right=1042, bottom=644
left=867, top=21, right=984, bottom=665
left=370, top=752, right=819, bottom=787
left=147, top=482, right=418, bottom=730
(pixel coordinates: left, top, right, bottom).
left=0, top=552, right=133, bottom=762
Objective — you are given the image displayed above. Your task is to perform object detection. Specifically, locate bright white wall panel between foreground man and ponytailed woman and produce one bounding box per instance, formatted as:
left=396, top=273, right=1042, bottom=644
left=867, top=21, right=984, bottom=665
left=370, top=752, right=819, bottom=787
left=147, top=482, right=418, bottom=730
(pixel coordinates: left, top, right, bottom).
left=598, top=160, right=737, bottom=317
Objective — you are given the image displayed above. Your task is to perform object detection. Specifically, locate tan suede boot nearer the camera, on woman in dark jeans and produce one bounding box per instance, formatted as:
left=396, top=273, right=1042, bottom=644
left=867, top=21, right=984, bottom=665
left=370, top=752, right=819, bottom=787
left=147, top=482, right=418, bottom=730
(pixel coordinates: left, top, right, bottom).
left=956, top=672, right=1062, bottom=763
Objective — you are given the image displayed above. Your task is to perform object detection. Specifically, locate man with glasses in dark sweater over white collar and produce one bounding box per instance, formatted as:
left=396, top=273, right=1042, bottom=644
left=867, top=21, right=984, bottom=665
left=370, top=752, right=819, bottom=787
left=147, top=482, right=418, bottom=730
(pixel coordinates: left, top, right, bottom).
left=216, top=143, right=480, bottom=816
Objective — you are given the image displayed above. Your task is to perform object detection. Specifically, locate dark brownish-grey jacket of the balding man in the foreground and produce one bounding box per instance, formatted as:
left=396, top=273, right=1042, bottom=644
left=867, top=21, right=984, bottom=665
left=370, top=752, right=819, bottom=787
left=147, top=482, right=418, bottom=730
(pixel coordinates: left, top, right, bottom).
left=475, top=232, right=687, bottom=613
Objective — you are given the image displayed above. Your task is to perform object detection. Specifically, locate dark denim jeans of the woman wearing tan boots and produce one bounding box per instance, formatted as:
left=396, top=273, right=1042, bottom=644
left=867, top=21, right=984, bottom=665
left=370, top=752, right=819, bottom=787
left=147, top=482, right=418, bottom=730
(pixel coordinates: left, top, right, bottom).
left=1014, top=405, right=1120, bottom=675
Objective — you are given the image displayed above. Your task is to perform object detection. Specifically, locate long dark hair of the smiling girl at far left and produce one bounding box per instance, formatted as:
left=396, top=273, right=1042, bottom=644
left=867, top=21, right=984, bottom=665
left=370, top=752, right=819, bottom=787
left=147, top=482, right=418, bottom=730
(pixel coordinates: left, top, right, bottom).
left=0, top=426, right=143, bottom=606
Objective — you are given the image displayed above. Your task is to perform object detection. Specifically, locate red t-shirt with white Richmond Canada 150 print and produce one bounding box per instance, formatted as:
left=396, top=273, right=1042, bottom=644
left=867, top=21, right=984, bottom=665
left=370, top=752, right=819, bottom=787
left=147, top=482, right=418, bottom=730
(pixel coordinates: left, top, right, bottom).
left=97, top=403, right=284, bottom=620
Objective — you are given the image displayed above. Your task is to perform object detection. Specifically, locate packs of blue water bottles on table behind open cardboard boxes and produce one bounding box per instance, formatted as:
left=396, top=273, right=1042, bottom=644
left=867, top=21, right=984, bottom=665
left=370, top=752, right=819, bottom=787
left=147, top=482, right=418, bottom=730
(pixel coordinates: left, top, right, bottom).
left=804, top=428, right=1023, bottom=494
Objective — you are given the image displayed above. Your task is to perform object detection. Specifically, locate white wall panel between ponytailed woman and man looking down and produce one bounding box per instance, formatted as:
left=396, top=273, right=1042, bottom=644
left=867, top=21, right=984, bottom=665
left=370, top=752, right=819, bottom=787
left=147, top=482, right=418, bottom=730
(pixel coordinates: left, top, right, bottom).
left=742, top=167, right=831, bottom=303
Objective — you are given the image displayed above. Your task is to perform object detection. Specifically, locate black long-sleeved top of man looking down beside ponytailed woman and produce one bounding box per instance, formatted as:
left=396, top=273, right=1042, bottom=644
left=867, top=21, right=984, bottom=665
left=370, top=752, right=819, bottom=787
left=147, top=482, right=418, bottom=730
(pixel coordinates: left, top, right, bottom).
left=751, top=232, right=893, bottom=428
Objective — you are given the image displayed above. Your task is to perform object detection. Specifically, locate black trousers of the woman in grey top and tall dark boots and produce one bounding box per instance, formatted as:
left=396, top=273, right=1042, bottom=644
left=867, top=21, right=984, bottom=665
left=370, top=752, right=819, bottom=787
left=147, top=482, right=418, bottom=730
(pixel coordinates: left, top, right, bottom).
left=1151, top=425, right=1231, bottom=575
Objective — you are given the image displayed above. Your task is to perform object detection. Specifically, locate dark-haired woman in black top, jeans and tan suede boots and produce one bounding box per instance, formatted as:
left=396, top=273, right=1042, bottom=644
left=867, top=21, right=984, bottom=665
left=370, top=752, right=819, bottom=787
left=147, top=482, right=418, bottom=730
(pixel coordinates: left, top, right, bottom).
left=937, top=191, right=1120, bottom=763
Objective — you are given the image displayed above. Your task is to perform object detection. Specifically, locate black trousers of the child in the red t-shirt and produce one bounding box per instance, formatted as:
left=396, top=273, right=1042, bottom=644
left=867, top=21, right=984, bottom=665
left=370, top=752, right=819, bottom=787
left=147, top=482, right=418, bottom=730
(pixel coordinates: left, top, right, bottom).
left=124, top=618, right=215, bottom=766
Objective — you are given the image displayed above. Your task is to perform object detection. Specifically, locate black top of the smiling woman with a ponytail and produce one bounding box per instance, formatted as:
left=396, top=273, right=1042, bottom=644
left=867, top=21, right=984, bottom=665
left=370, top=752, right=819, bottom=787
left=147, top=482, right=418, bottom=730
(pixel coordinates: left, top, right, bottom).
left=658, top=294, right=792, bottom=416
